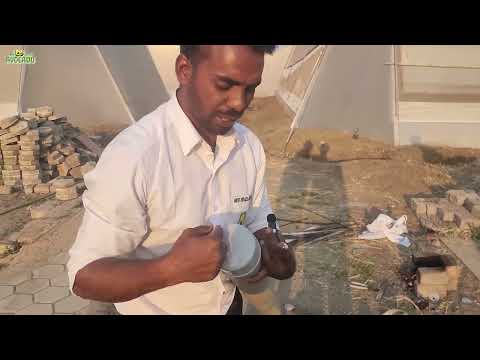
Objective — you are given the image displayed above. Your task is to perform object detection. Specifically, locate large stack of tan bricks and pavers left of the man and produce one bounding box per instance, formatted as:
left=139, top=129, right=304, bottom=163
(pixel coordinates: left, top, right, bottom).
left=0, top=106, right=96, bottom=200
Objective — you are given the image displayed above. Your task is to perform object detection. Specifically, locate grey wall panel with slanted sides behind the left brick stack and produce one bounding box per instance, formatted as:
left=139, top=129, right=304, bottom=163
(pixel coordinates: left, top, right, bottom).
left=22, top=45, right=132, bottom=132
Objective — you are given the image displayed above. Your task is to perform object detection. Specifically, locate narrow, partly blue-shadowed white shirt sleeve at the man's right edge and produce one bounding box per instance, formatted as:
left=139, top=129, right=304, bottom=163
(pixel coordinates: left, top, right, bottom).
left=246, top=141, right=272, bottom=233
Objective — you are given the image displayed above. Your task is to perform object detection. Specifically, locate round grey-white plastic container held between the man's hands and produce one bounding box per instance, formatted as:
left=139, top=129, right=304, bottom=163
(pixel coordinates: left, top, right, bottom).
left=221, top=224, right=262, bottom=279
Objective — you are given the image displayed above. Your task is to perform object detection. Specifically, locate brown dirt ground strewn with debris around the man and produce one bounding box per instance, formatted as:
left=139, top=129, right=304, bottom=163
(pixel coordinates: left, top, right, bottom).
left=0, top=98, right=480, bottom=314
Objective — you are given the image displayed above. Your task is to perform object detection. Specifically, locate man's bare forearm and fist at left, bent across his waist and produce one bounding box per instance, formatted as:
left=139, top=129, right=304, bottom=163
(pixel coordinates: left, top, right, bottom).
left=73, top=226, right=225, bottom=303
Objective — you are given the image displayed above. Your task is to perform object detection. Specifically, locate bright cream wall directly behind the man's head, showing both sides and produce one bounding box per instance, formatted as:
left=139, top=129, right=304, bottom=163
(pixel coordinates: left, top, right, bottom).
left=148, top=45, right=291, bottom=97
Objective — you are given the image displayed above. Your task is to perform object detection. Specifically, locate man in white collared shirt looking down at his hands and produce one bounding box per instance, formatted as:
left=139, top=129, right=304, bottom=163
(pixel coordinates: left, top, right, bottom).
left=68, top=45, right=296, bottom=314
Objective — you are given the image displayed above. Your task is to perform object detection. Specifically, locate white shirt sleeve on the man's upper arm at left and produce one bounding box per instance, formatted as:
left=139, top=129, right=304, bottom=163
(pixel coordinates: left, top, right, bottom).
left=67, top=136, right=147, bottom=290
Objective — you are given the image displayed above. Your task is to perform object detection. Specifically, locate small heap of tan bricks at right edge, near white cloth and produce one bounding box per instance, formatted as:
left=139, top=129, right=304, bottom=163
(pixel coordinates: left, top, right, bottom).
left=410, top=190, right=480, bottom=230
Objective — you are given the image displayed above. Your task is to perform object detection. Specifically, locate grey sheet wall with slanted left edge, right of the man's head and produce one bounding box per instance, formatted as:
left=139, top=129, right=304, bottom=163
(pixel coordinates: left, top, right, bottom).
left=297, top=45, right=395, bottom=143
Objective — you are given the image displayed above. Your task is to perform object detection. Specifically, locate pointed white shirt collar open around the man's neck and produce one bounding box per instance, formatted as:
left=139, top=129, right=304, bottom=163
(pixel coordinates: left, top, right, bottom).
left=171, top=94, right=241, bottom=156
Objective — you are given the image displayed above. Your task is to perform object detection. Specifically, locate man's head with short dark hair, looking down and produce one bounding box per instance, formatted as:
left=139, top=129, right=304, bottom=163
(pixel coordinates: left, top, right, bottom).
left=176, top=45, right=275, bottom=136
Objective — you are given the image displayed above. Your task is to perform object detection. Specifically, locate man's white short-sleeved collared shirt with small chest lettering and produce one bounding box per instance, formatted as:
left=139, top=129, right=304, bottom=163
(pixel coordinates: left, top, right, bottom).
left=67, top=95, right=271, bottom=314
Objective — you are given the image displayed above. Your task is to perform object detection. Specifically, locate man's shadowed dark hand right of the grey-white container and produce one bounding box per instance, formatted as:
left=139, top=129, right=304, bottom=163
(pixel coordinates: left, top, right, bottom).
left=246, top=228, right=297, bottom=283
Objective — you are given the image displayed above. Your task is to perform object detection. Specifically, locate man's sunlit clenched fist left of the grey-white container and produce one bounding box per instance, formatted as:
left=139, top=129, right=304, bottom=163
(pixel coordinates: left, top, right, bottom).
left=168, top=225, right=226, bottom=283
